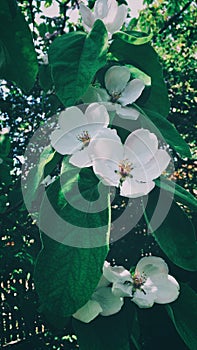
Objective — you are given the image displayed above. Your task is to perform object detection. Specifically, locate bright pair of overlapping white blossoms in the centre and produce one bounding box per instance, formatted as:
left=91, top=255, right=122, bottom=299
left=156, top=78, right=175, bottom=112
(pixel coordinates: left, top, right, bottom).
left=51, top=98, right=170, bottom=198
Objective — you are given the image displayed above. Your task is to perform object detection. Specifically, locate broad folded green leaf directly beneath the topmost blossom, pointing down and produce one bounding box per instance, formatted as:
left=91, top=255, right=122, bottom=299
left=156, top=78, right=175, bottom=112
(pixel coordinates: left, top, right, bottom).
left=49, top=20, right=108, bottom=107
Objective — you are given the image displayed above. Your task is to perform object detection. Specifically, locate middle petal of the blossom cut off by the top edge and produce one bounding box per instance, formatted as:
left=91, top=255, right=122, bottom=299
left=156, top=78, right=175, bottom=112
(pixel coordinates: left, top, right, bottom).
left=94, top=0, right=115, bottom=19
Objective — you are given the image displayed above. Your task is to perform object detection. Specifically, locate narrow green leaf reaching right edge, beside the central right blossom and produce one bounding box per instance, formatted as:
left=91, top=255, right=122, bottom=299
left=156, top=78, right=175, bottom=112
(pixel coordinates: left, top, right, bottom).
left=154, top=176, right=197, bottom=210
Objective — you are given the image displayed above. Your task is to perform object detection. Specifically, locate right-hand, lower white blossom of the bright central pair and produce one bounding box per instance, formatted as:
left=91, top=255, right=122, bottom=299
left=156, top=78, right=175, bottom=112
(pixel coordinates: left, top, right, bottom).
left=89, top=129, right=170, bottom=198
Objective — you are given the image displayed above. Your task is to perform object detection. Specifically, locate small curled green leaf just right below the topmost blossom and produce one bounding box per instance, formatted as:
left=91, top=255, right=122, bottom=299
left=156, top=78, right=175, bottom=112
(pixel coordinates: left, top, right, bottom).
left=112, top=30, right=153, bottom=45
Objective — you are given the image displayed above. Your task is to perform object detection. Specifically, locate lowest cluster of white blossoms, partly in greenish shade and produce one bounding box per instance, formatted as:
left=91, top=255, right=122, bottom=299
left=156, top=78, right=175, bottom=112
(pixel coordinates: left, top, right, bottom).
left=73, top=256, right=179, bottom=323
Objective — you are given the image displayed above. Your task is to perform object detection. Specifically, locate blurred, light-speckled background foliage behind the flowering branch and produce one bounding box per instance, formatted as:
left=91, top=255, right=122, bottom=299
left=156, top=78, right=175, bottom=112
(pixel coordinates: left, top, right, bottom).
left=0, top=0, right=197, bottom=350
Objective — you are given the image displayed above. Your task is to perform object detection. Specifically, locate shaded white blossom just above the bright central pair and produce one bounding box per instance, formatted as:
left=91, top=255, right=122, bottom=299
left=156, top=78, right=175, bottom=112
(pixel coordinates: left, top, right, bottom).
left=83, top=66, right=145, bottom=120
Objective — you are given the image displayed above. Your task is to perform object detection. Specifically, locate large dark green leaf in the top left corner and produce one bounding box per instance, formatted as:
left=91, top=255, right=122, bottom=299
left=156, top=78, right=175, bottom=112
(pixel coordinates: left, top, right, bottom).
left=0, top=0, right=38, bottom=93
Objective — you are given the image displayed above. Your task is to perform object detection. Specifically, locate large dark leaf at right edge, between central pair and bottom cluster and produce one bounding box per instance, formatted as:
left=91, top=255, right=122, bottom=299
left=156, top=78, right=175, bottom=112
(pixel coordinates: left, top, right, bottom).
left=145, top=188, right=197, bottom=271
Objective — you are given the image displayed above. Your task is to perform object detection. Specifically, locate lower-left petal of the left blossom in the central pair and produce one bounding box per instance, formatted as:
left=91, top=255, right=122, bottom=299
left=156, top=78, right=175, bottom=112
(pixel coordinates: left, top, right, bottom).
left=50, top=129, right=81, bottom=154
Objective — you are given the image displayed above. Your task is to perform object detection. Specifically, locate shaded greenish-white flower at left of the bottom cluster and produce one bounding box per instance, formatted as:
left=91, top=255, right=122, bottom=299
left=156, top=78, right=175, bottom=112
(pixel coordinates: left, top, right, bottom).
left=73, top=276, right=124, bottom=323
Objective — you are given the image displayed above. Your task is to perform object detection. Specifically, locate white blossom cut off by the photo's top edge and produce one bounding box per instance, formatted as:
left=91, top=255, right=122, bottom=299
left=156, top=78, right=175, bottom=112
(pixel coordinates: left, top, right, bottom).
left=79, top=0, right=127, bottom=34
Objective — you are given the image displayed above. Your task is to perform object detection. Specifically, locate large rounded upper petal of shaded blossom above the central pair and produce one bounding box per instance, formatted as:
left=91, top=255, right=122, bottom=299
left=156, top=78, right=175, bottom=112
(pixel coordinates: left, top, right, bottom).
left=105, top=66, right=130, bottom=95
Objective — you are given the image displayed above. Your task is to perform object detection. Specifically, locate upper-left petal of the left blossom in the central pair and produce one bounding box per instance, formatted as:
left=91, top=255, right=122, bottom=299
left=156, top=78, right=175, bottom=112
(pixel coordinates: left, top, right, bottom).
left=58, top=107, right=87, bottom=132
